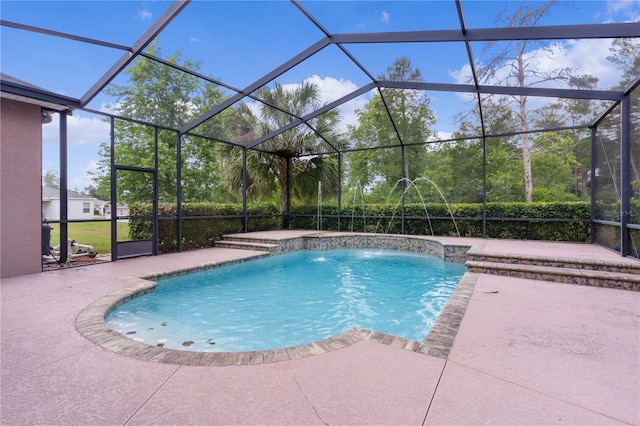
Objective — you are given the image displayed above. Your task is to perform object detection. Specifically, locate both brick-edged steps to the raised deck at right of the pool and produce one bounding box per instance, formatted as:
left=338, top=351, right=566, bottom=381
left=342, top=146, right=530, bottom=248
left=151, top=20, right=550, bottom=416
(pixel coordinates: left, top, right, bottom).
left=466, top=253, right=640, bottom=291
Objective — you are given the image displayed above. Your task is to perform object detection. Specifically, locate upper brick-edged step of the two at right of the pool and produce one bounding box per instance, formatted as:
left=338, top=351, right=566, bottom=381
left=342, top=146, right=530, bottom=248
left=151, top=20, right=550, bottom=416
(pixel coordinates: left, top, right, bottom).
left=467, top=252, right=640, bottom=275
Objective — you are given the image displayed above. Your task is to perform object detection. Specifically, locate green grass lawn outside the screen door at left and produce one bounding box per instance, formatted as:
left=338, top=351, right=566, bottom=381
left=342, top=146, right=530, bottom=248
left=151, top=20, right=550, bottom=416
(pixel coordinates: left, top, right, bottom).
left=49, top=222, right=129, bottom=254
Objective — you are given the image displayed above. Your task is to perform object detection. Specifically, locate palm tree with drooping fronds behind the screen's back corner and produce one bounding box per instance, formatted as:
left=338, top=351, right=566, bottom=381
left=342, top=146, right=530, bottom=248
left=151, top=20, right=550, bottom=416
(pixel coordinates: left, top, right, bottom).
left=225, top=82, right=346, bottom=228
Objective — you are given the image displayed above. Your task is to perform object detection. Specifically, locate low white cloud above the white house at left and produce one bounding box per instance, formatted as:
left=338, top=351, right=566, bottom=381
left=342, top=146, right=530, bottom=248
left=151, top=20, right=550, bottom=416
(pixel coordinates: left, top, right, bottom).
left=42, top=114, right=109, bottom=147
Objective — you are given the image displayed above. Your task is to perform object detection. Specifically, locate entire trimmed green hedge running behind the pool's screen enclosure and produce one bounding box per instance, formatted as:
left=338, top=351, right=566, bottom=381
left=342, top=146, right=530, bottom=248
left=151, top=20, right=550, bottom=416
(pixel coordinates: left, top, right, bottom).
left=129, top=202, right=596, bottom=252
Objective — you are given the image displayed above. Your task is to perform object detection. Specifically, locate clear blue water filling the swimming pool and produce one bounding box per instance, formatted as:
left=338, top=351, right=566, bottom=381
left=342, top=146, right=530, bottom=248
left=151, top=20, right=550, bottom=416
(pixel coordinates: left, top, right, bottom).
left=105, top=249, right=466, bottom=352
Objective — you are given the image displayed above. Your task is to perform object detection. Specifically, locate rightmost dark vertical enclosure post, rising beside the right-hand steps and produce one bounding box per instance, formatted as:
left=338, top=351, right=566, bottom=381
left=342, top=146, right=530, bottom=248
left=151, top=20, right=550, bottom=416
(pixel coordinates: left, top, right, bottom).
left=620, top=94, right=631, bottom=256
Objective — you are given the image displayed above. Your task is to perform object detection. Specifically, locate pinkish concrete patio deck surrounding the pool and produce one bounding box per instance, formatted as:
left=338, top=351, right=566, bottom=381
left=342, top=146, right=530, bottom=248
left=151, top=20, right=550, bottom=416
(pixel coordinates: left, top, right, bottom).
left=0, top=232, right=640, bottom=425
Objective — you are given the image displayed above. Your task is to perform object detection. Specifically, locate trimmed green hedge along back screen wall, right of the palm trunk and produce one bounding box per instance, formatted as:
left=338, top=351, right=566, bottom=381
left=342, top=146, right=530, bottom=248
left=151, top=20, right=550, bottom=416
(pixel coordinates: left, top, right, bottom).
left=291, top=202, right=591, bottom=242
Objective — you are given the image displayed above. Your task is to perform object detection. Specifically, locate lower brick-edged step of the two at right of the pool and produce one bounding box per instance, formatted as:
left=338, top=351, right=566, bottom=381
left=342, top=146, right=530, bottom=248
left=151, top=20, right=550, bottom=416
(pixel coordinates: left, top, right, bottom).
left=466, top=260, right=640, bottom=291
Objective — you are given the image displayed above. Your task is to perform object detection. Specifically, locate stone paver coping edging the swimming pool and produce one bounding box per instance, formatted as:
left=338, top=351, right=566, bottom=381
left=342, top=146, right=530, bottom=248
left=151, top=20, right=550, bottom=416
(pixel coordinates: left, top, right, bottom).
left=76, top=236, right=478, bottom=366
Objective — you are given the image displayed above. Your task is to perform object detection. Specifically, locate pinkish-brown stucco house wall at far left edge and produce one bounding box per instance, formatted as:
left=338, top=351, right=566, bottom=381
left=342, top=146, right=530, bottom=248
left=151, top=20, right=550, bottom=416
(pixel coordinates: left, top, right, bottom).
left=0, top=99, right=42, bottom=277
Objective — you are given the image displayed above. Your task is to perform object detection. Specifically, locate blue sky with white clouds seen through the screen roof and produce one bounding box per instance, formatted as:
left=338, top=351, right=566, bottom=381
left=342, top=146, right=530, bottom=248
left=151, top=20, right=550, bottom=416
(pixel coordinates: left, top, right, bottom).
left=0, top=0, right=640, bottom=190
